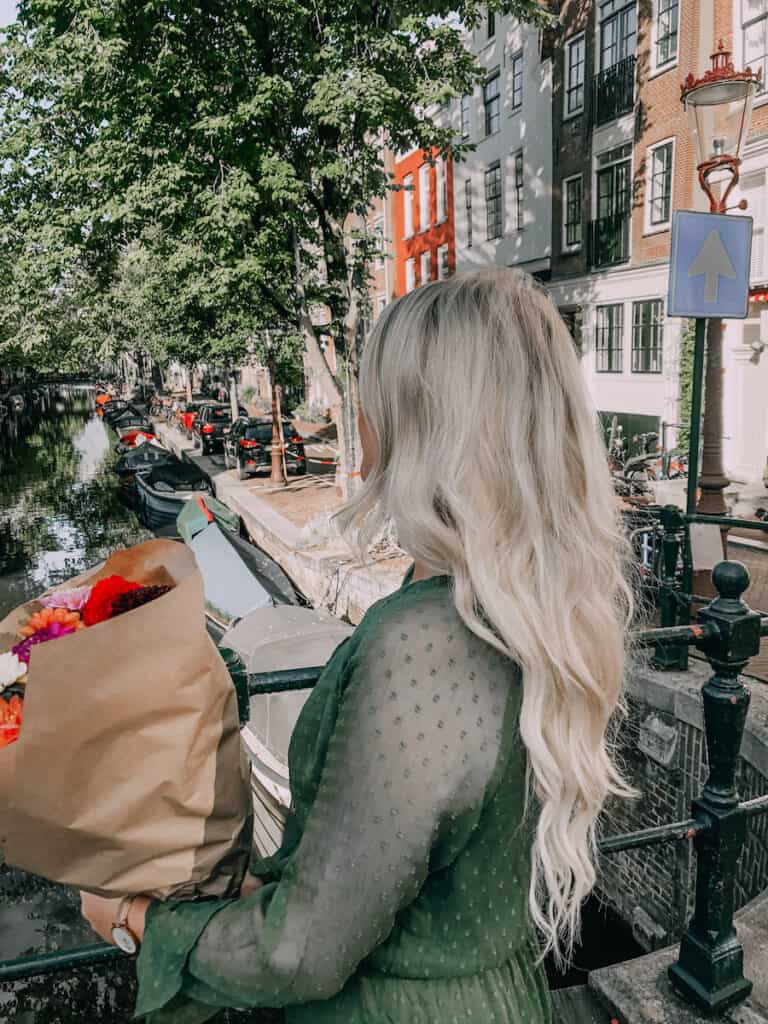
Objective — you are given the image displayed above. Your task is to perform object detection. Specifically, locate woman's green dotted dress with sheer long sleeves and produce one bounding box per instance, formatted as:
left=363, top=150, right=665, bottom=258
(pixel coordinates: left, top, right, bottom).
left=136, top=566, right=552, bottom=1024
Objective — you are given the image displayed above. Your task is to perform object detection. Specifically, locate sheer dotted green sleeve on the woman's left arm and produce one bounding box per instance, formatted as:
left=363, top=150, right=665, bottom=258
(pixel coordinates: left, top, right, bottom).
left=138, top=602, right=511, bottom=1013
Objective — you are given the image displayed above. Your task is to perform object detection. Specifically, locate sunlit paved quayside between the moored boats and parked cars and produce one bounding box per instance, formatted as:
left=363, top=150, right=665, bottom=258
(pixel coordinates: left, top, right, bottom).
left=156, top=423, right=413, bottom=626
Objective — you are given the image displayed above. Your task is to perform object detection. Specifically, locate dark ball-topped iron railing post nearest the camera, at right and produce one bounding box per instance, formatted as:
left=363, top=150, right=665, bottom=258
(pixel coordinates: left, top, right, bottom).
left=669, top=562, right=761, bottom=1014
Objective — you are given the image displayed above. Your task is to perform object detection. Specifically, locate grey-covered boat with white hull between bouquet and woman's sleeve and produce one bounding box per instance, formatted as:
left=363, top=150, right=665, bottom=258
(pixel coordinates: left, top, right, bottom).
left=220, top=605, right=354, bottom=856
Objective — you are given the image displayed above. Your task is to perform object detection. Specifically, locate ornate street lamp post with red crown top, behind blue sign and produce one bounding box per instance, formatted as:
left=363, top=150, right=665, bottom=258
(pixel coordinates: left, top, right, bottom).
left=681, top=40, right=760, bottom=515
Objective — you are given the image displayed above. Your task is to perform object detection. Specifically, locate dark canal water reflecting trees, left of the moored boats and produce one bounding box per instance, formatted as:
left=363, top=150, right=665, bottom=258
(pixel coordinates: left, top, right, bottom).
left=0, top=390, right=275, bottom=1024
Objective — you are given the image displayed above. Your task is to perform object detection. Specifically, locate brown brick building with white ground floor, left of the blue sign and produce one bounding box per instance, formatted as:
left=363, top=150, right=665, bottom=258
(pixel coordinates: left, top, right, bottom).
left=552, top=0, right=714, bottom=448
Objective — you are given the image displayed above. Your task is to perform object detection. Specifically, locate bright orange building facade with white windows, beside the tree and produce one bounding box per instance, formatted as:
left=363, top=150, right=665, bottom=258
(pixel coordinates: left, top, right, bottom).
left=392, top=150, right=456, bottom=297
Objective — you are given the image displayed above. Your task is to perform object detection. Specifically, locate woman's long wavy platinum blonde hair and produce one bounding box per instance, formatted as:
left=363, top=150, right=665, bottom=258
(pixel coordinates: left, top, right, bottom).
left=334, top=268, right=638, bottom=966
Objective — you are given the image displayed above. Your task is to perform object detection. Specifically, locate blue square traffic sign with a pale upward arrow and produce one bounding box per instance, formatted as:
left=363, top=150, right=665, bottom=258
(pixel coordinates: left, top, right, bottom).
left=667, top=210, right=752, bottom=319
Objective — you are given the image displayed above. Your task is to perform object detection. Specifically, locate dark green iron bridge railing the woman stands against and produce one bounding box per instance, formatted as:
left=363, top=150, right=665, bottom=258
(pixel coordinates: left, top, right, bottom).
left=0, top=561, right=768, bottom=1013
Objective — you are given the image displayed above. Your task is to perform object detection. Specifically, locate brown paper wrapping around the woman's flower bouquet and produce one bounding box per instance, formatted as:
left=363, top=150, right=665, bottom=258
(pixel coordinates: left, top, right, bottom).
left=0, top=541, right=251, bottom=899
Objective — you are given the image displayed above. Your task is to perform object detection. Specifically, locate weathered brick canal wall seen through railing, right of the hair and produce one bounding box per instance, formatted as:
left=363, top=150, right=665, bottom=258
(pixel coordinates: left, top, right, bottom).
left=598, top=684, right=768, bottom=948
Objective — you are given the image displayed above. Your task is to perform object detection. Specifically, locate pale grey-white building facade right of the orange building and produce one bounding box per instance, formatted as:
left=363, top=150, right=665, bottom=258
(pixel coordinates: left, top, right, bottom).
left=452, top=14, right=552, bottom=282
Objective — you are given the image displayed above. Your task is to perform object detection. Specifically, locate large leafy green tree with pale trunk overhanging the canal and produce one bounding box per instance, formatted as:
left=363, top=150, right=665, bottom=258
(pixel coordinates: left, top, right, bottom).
left=0, top=0, right=547, bottom=495
